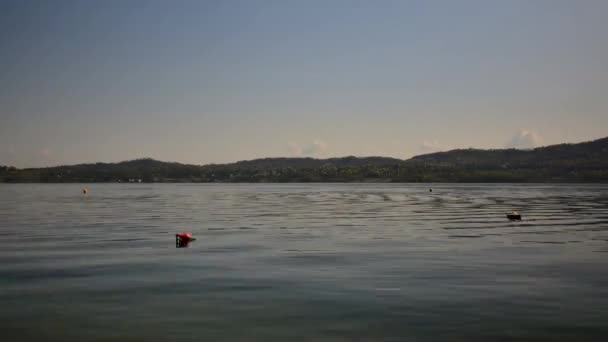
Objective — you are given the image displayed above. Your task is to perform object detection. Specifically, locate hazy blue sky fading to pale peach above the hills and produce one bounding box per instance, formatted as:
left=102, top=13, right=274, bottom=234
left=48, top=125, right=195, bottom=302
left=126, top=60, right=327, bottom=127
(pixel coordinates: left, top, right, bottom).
left=0, top=0, right=608, bottom=167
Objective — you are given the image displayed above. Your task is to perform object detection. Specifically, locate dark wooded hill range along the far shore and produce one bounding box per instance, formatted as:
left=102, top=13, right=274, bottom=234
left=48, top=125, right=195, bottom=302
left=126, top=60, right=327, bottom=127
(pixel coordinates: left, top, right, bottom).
left=0, top=138, right=608, bottom=183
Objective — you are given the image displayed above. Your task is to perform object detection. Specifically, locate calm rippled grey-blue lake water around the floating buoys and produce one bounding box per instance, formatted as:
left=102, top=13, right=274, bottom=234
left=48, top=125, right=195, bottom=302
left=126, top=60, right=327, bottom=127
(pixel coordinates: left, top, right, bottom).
left=0, top=184, right=608, bottom=341
